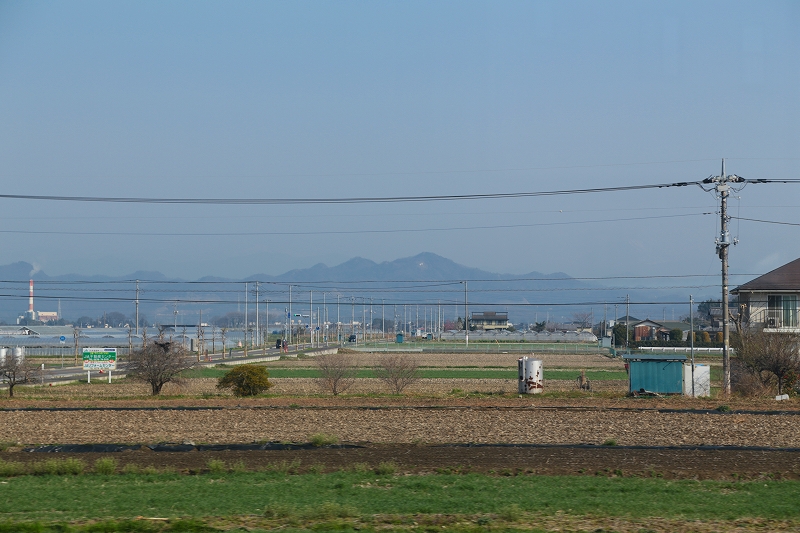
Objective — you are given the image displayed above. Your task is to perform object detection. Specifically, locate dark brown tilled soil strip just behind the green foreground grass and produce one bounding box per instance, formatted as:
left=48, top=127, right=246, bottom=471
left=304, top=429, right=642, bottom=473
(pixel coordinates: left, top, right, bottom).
left=0, top=443, right=800, bottom=480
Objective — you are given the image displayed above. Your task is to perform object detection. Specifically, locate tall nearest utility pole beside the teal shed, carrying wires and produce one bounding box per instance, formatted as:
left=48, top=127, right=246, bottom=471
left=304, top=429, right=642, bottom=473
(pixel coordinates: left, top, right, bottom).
left=703, top=159, right=745, bottom=395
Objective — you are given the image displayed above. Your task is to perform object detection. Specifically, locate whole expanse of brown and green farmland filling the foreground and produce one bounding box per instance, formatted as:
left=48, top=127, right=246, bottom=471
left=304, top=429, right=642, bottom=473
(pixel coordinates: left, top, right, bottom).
left=0, top=353, right=800, bottom=531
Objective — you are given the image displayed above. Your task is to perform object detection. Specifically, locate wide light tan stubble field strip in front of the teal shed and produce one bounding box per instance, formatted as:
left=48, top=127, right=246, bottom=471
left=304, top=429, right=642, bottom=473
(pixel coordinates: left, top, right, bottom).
left=0, top=404, right=800, bottom=448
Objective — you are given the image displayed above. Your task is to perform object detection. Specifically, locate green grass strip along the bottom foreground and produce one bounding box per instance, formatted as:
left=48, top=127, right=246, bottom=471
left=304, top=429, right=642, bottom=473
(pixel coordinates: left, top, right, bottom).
left=0, top=464, right=800, bottom=531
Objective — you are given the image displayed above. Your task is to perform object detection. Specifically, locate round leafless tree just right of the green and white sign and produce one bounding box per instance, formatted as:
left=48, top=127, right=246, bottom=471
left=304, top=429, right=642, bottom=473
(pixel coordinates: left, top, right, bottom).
left=128, top=340, right=195, bottom=396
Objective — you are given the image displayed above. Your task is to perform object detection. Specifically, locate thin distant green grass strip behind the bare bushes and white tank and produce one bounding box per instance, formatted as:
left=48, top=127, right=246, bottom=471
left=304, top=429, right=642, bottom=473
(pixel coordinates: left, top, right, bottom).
left=184, top=367, right=628, bottom=380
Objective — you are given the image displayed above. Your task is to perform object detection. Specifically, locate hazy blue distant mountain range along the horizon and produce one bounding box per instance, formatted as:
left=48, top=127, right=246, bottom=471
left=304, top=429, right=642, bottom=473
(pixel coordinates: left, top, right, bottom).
left=0, top=252, right=712, bottom=323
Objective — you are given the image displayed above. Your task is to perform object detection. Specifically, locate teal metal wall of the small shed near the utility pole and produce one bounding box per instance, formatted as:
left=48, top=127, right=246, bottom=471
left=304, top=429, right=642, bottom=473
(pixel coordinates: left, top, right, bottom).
left=622, top=353, right=686, bottom=394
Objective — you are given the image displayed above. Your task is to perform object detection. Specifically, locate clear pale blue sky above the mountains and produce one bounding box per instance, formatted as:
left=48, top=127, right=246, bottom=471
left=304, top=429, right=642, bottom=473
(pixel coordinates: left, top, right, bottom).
left=0, top=0, right=800, bottom=279
